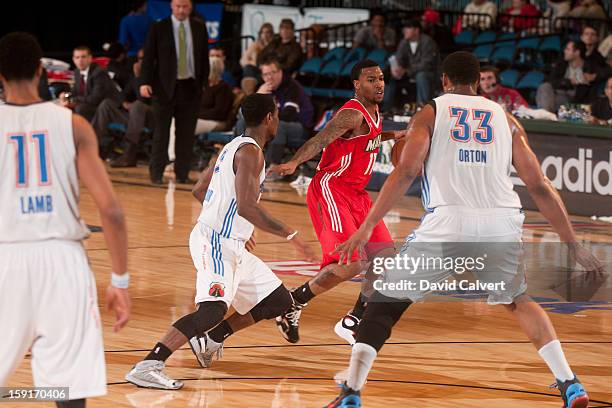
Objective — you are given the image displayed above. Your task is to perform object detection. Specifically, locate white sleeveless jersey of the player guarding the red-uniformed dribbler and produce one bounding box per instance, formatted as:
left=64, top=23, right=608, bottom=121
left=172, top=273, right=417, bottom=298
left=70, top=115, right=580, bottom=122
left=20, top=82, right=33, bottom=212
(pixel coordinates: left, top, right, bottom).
left=198, top=136, right=266, bottom=241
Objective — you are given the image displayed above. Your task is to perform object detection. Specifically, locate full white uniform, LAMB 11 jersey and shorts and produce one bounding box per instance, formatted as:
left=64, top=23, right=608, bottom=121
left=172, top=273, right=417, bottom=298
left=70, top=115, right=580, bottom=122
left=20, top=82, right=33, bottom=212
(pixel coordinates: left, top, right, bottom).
left=0, top=102, right=106, bottom=399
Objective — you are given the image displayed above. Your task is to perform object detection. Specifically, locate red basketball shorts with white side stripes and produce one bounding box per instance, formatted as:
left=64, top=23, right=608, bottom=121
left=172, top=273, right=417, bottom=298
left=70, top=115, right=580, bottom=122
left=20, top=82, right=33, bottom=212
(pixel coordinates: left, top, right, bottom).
left=306, top=173, right=393, bottom=268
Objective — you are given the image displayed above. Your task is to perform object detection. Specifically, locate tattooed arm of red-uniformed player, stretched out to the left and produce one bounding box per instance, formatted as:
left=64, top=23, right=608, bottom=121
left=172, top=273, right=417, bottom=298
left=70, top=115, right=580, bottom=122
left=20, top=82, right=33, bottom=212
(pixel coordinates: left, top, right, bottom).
left=270, top=109, right=363, bottom=176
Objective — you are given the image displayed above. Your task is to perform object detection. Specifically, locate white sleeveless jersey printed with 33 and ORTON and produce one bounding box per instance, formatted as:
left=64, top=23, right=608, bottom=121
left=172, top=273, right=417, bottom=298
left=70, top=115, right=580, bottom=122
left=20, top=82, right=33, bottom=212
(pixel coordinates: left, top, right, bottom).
left=421, top=94, right=521, bottom=211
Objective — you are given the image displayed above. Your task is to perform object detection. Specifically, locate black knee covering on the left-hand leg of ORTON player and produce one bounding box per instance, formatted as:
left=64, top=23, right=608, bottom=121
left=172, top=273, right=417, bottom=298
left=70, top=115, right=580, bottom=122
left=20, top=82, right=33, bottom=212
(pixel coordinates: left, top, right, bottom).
left=357, top=299, right=412, bottom=352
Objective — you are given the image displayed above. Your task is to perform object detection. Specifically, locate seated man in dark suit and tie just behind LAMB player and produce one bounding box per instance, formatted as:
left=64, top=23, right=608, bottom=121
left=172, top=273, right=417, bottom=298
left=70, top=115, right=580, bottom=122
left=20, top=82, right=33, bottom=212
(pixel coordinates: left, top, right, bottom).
left=60, top=45, right=119, bottom=121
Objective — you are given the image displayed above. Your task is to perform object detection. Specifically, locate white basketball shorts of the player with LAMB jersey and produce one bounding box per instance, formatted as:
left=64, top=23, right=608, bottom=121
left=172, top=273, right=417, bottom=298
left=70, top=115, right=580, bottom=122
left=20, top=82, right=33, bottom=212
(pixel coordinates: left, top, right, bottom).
left=0, top=240, right=106, bottom=400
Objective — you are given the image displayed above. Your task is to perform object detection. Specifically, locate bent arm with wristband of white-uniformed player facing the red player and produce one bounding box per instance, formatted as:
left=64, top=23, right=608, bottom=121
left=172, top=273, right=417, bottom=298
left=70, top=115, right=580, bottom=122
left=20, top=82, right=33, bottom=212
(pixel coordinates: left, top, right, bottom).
left=234, top=144, right=314, bottom=260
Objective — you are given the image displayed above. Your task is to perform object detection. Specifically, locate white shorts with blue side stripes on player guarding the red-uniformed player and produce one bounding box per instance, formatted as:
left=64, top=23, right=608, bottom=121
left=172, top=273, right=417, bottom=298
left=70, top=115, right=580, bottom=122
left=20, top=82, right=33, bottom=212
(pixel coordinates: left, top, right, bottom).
left=189, top=223, right=282, bottom=315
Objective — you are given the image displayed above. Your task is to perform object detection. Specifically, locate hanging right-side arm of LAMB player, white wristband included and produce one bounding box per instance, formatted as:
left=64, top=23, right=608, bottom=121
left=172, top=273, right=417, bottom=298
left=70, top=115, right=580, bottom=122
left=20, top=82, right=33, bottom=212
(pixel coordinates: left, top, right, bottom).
left=72, top=115, right=131, bottom=330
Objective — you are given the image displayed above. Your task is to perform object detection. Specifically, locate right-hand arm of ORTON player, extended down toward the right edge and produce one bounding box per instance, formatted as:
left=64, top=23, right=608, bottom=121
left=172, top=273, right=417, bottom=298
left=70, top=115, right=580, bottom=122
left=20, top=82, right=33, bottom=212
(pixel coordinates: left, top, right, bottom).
left=507, top=114, right=603, bottom=271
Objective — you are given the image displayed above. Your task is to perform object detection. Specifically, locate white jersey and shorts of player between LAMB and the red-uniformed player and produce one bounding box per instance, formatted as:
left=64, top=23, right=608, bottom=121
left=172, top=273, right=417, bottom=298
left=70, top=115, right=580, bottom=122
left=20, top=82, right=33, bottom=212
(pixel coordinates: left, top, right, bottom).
left=189, top=136, right=282, bottom=314
